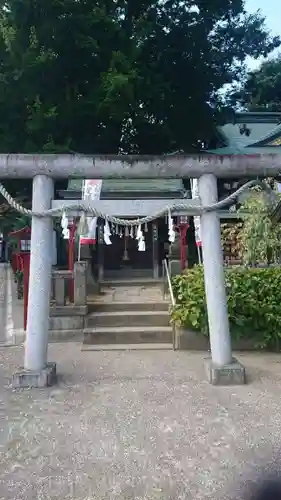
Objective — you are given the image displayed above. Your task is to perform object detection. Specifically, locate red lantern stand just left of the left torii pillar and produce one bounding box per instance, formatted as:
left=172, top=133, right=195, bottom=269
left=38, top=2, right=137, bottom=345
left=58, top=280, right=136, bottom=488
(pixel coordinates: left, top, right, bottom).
left=9, top=227, right=31, bottom=330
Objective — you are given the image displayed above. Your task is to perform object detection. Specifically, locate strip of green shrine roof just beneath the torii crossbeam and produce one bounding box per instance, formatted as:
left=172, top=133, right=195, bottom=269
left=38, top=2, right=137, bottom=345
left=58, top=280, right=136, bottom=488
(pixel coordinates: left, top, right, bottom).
left=67, top=179, right=183, bottom=193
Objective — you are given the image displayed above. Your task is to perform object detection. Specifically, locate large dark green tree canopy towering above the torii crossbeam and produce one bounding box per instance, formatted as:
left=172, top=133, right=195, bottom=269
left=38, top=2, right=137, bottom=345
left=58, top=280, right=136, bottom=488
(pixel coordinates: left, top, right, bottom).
left=0, top=0, right=280, bottom=158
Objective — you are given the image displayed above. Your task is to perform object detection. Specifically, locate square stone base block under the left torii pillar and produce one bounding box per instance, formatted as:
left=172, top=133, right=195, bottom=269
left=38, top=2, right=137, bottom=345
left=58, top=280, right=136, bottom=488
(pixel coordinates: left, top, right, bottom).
left=12, top=363, right=57, bottom=389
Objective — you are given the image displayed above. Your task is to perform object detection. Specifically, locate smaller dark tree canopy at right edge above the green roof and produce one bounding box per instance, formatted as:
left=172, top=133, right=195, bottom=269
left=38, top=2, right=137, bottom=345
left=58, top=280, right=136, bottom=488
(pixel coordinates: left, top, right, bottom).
left=232, top=54, right=281, bottom=111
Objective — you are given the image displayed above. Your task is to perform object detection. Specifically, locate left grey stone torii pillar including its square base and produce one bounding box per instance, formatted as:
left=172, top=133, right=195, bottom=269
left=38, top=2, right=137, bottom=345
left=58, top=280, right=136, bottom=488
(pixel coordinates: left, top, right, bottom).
left=13, top=175, right=56, bottom=387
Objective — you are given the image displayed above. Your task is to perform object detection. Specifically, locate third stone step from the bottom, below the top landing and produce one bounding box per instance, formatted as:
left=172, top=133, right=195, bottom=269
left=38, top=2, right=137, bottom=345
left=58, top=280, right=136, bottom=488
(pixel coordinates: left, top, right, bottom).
left=88, top=300, right=167, bottom=313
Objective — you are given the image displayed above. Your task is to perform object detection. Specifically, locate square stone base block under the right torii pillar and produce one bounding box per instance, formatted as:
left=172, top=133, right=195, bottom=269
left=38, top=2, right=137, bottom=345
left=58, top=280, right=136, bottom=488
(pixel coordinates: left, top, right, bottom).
left=205, top=358, right=246, bottom=385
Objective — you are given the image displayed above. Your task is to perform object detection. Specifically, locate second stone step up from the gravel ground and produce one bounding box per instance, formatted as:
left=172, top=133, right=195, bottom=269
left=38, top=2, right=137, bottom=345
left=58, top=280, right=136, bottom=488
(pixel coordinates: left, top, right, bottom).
left=85, top=310, right=170, bottom=328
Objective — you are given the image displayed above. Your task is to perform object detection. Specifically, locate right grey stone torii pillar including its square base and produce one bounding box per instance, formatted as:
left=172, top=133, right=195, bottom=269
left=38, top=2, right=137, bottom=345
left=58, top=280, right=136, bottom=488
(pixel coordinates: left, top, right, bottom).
left=198, top=174, right=245, bottom=385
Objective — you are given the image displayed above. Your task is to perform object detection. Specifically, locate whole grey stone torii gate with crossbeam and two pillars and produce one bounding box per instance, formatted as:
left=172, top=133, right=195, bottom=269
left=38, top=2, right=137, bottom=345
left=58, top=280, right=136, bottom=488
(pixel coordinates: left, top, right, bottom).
left=0, top=154, right=281, bottom=387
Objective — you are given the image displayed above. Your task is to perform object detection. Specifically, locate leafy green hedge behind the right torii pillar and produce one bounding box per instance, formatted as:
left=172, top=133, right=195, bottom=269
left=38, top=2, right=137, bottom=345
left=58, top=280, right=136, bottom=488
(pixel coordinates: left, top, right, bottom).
left=172, top=266, right=281, bottom=350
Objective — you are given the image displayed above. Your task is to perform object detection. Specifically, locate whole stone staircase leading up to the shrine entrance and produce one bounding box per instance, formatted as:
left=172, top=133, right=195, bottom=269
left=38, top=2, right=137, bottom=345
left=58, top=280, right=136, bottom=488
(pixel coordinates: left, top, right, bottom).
left=82, top=279, right=173, bottom=350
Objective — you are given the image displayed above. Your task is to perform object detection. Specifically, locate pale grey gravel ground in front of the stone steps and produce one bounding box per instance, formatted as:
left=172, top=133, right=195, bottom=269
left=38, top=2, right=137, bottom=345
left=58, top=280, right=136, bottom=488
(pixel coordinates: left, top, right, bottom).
left=0, top=344, right=281, bottom=500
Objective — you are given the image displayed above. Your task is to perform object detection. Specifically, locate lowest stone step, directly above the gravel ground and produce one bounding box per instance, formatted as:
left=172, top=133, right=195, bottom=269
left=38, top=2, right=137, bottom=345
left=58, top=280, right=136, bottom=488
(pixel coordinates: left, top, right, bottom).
left=84, top=326, right=173, bottom=345
